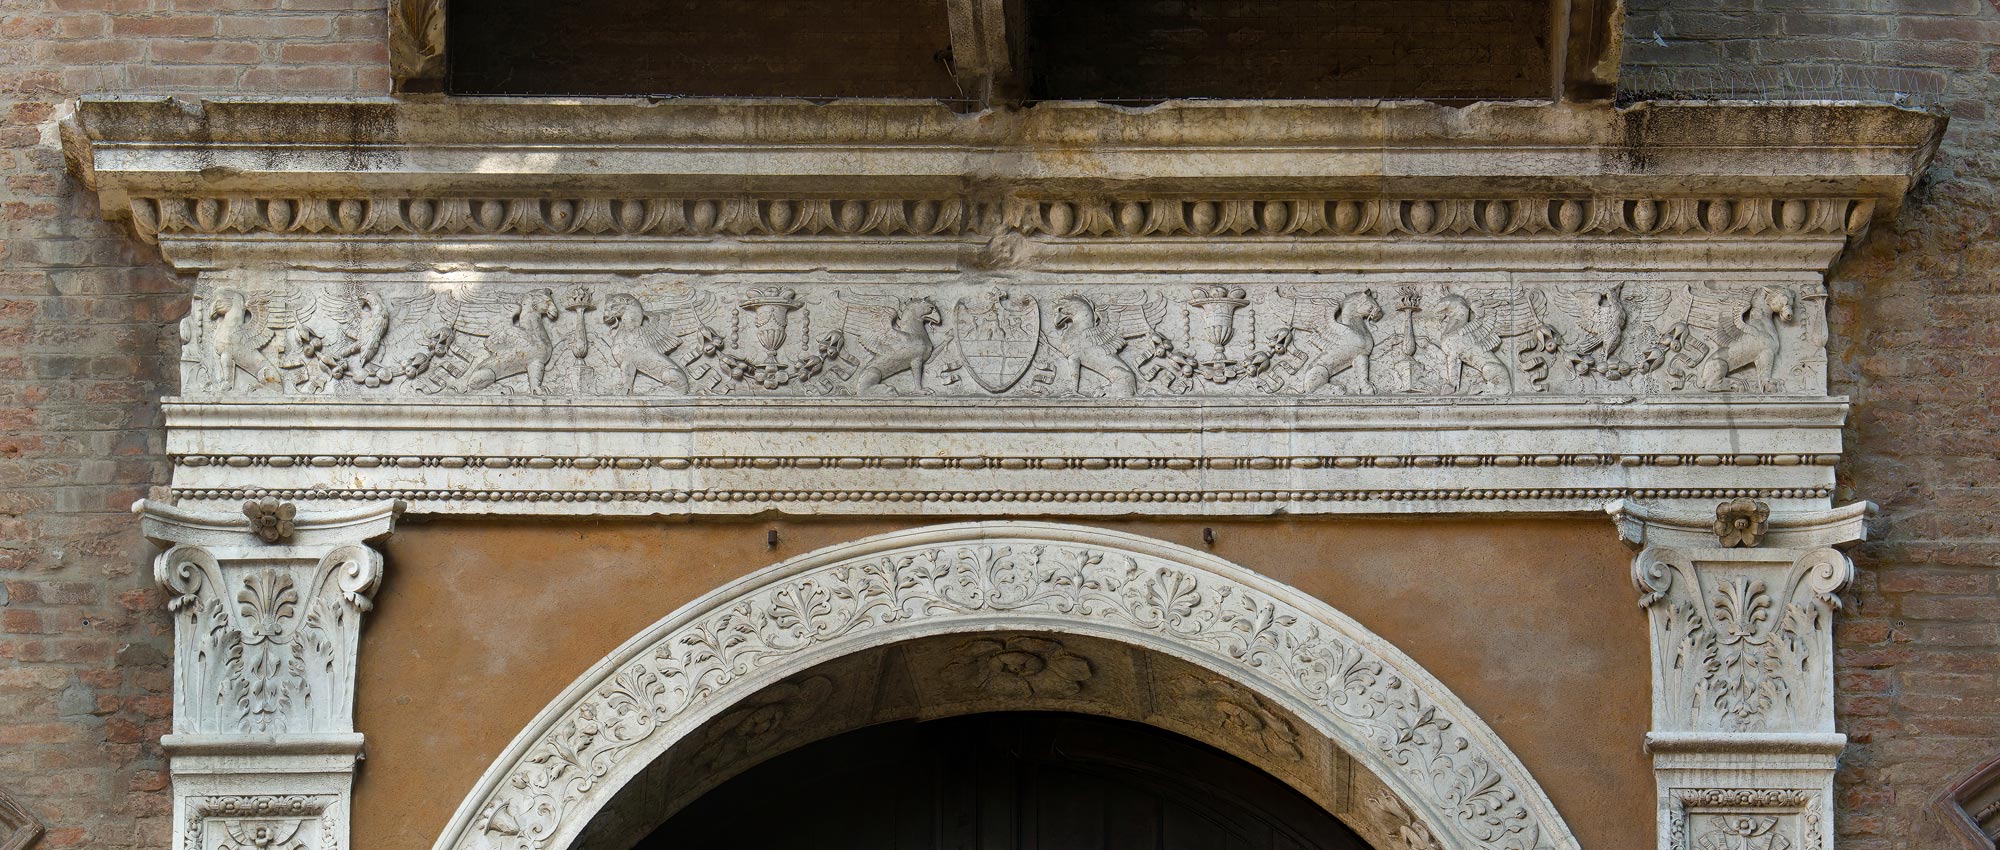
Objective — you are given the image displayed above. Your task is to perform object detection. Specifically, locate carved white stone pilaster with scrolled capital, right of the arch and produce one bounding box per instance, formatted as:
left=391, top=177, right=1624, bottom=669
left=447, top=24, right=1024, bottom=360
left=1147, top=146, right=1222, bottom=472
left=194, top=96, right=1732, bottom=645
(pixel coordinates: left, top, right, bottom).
left=1610, top=500, right=1872, bottom=850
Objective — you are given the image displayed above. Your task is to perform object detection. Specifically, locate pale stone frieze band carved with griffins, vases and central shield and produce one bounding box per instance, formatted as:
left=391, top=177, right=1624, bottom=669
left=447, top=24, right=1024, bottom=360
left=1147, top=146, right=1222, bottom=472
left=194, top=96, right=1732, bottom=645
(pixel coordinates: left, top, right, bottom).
left=182, top=276, right=1824, bottom=398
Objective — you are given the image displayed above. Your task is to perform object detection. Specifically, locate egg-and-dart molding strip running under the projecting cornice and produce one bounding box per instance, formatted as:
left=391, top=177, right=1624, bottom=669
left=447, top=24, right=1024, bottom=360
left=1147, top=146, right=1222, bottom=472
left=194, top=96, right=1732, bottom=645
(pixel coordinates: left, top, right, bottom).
left=130, top=196, right=1874, bottom=240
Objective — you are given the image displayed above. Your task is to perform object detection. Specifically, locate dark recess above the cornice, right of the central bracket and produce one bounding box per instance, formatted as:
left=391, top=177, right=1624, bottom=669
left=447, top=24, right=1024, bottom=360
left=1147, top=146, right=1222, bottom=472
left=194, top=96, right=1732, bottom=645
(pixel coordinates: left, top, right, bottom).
left=1026, top=0, right=1550, bottom=102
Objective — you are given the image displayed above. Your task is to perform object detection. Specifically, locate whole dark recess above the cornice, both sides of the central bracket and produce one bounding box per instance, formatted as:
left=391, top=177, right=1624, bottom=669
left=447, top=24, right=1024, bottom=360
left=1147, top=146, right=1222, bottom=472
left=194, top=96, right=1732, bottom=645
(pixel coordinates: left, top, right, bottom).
left=446, top=0, right=1552, bottom=104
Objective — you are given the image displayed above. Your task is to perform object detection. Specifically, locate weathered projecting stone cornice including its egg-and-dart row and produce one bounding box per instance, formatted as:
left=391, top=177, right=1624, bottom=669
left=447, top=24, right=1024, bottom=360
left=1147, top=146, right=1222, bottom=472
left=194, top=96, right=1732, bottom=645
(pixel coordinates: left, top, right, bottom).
left=70, top=98, right=1944, bottom=268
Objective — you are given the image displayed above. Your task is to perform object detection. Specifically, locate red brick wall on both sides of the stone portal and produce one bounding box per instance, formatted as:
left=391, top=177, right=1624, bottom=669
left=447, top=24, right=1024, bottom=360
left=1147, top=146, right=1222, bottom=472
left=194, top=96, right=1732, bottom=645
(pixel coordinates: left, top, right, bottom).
left=0, top=0, right=2000, bottom=850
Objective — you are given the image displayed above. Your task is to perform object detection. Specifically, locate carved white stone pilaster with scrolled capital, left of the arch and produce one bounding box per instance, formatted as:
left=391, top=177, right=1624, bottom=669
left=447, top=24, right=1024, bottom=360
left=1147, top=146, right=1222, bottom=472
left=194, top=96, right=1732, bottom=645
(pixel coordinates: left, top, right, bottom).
left=134, top=498, right=402, bottom=850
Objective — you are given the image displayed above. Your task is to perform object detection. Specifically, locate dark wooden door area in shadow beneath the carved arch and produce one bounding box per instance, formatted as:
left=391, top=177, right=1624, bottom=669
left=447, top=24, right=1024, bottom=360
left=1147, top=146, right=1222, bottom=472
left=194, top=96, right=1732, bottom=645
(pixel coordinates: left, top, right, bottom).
left=636, top=712, right=1366, bottom=850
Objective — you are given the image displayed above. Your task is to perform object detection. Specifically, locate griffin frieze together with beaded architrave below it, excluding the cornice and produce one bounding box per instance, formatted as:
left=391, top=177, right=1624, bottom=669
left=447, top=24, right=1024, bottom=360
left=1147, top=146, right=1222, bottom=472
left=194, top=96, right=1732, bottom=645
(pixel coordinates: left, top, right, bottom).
left=168, top=270, right=1844, bottom=514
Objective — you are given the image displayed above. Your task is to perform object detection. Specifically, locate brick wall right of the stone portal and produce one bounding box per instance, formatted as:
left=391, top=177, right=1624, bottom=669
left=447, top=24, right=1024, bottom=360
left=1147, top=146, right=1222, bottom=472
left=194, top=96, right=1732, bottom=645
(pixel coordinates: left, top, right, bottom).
left=1626, top=0, right=2000, bottom=850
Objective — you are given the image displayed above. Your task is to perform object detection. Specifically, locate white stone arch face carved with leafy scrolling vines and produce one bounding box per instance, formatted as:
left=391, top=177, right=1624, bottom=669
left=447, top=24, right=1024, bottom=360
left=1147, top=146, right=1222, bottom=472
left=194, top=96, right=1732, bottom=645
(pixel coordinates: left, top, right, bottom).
left=434, top=522, right=1578, bottom=850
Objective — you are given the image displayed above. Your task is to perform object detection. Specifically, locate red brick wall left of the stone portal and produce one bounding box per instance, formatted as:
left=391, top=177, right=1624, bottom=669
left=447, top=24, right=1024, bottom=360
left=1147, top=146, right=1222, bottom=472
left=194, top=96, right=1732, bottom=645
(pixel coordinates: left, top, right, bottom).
left=0, top=0, right=388, bottom=850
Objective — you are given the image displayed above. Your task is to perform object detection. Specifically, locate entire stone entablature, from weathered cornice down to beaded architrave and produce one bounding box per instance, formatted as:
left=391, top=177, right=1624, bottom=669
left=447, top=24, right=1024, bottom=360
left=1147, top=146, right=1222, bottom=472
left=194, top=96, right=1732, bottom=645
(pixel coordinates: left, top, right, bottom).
left=68, top=100, right=1940, bottom=514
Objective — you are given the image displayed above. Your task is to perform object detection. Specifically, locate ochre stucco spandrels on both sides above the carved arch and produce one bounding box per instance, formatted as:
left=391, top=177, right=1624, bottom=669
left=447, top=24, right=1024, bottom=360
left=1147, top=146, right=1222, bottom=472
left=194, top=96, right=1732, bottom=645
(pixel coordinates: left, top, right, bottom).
left=354, top=518, right=1654, bottom=850
